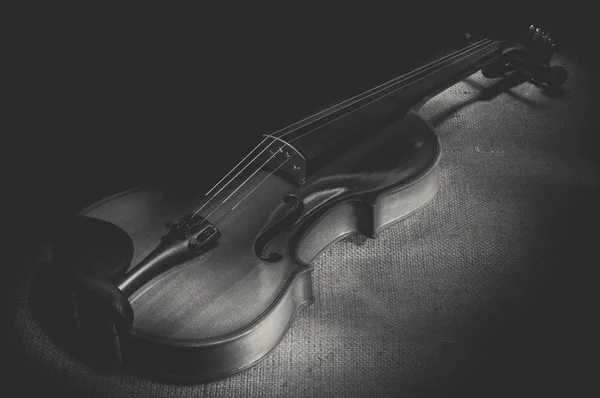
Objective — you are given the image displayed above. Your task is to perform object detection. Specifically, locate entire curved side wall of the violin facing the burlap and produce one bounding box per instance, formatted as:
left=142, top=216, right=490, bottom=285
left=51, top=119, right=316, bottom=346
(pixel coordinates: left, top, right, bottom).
left=123, top=158, right=440, bottom=383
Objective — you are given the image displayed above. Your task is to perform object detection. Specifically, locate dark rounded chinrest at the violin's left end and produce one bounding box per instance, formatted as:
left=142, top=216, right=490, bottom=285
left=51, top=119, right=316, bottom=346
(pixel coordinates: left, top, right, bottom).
left=53, top=216, right=134, bottom=365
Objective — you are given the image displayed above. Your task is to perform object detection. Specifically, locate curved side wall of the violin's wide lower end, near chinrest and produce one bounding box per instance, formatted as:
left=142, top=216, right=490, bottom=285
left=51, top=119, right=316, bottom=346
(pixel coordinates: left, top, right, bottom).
left=123, top=267, right=314, bottom=383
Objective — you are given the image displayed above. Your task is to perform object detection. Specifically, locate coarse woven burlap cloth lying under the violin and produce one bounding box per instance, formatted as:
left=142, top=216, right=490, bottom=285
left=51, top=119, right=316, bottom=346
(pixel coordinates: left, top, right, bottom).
left=7, top=54, right=600, bottom=397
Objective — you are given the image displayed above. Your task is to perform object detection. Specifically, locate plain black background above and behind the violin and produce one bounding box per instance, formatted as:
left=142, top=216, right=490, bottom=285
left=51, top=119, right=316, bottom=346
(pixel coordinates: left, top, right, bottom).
left=3, top=4, right=597, bottom=394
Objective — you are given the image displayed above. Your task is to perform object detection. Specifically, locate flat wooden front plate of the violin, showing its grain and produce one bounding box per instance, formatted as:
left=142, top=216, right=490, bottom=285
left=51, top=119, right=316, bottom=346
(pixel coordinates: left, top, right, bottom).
left=82, top=109, right=439, bottom=341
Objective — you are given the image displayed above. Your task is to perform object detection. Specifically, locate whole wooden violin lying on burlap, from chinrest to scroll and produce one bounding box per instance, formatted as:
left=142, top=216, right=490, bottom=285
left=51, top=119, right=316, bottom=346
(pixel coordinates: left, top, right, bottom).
left=53, top=26, right=567, bottom=383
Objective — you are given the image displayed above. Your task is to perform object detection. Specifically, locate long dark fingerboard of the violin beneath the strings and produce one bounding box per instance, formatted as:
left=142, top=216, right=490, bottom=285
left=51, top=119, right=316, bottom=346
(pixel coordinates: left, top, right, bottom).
left=283, top=40, right=501, bottom=174
